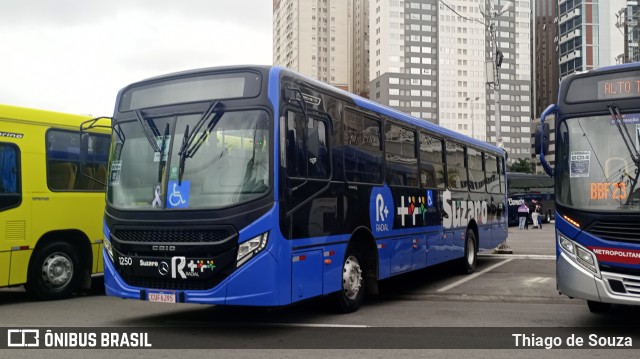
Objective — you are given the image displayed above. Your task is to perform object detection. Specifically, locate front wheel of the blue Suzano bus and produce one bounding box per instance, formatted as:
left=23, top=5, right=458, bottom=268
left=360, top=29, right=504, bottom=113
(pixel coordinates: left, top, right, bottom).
left=334, top=248, right=366, bottom=313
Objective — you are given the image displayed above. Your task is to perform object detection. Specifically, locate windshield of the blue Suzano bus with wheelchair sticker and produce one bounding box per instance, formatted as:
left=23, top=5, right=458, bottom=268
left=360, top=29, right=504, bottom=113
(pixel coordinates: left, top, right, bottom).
left=107, top=110, right=271, bottom=210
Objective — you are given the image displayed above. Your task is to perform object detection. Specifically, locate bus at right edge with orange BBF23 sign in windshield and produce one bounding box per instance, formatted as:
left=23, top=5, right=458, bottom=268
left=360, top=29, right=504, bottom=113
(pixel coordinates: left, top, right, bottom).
left=535, top=63, right=640, bottom=312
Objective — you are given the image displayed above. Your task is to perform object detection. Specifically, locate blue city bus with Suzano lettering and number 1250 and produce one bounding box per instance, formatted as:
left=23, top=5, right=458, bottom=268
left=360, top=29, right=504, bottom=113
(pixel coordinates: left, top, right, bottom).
left=104, top=66, right=507, bottom=312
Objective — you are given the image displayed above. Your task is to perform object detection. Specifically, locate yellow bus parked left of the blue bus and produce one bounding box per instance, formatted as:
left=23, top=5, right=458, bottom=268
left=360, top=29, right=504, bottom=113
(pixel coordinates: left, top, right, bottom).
left=0, top=105, right=110, bottom=299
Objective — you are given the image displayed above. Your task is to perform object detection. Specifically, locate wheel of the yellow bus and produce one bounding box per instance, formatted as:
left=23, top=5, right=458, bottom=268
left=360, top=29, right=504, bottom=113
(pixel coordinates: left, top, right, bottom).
left=26, top=241, right=81, bottom=300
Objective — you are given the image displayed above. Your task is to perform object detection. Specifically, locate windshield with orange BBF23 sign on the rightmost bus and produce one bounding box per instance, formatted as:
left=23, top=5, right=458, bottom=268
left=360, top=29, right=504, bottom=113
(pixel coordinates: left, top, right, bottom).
left=556, top=114, right=640, bottom=212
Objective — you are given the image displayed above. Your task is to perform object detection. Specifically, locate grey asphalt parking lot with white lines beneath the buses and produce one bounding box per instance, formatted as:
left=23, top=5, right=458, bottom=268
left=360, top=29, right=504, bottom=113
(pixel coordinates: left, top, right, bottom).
left=0, top=225, right=640, bottom=357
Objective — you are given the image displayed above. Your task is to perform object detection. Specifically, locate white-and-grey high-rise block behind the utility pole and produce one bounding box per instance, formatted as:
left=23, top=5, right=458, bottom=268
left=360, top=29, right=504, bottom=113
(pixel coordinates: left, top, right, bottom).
left=369, top=0, right=532, bottom=161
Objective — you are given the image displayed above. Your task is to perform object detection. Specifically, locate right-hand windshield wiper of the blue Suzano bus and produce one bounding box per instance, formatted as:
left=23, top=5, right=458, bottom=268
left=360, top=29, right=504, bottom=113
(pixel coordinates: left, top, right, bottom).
left=178, top=101, right=224, bottom=186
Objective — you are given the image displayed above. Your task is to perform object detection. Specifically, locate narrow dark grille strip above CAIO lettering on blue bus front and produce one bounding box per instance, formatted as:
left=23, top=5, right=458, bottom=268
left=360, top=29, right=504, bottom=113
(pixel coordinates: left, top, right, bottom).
left=112, top=228, right=235, bottom=243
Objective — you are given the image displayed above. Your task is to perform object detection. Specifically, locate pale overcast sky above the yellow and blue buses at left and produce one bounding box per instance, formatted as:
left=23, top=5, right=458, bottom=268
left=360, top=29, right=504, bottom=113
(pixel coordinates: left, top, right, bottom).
left=0, top=0, right=272, bottom=116
